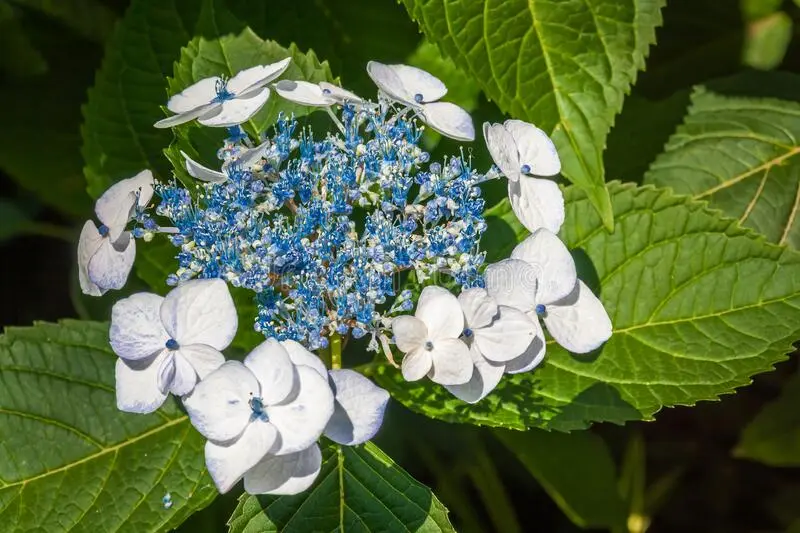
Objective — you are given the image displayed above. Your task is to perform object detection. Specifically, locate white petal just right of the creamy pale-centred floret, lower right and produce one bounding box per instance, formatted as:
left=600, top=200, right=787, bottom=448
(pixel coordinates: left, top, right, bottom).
left=472, top=305, right=538, bottom=363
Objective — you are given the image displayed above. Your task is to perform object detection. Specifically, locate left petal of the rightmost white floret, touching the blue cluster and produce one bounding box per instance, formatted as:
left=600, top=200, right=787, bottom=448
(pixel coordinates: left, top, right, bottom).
left=483, top=259, right=539, bottom=312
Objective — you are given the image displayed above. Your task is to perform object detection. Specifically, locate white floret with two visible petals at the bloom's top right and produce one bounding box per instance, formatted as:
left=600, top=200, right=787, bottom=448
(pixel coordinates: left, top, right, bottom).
left=367, top=61, right=475, bottom=141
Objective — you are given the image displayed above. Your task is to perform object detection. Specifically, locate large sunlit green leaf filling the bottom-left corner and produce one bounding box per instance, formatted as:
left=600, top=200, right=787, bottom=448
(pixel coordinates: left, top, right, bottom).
left=0, top=320, right=216, bottom=533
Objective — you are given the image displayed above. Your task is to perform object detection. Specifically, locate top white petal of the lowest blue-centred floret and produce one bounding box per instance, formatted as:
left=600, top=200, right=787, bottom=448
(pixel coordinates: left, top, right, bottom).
left=244, top=339, right=298, bottom=405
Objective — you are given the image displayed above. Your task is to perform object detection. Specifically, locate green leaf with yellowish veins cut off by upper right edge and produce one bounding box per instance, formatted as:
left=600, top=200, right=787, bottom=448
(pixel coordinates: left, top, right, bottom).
left=645, top=87, right=800, bottom=248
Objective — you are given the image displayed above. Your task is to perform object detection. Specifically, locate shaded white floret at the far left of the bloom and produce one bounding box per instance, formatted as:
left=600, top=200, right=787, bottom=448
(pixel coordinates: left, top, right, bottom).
left=78, top=170, right=153, bottom=296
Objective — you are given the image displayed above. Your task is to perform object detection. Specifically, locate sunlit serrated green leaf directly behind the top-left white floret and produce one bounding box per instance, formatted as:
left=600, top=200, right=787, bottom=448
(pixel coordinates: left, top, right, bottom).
left=169, top=28, right=335, bottom=134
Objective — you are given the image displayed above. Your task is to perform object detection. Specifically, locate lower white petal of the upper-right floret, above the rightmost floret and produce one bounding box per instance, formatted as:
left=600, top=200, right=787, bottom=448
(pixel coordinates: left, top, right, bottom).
left=508, top=176, right=565, bottom=233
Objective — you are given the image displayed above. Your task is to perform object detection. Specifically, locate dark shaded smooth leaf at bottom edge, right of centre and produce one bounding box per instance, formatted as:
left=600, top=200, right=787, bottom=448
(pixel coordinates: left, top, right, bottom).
left=495, top=429, right=627, bottom=529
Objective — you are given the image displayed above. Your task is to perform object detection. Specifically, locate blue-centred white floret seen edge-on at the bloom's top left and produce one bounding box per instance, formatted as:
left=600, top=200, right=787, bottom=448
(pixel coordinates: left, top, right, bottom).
left=154, top=57, right=291, bottom=128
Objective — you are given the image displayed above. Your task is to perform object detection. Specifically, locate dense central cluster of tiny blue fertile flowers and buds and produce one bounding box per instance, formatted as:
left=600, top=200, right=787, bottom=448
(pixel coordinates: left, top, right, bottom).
left=142, top=102, right=487, bottom=349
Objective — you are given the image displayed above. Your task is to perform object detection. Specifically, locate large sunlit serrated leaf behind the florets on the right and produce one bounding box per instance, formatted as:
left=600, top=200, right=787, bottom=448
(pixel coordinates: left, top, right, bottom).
left=376, top=183, right=800, bottom=431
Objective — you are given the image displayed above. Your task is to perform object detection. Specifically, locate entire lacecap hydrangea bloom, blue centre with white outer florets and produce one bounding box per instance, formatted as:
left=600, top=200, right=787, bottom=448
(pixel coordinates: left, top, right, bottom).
left=79, top=59, right=611, bottom=494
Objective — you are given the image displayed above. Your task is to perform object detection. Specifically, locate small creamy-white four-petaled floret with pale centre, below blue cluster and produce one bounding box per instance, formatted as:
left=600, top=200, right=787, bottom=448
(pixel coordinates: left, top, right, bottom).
left=392, top=286, right=473, bottom=385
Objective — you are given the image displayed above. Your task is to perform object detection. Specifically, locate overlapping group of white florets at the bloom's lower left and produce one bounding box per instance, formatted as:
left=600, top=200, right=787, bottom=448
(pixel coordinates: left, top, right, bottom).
left=110, top=279, right=389, bottom=494
